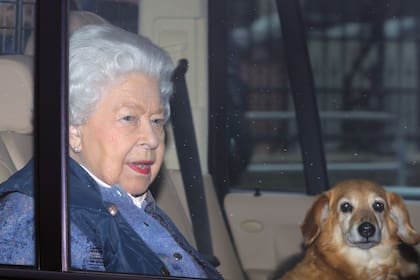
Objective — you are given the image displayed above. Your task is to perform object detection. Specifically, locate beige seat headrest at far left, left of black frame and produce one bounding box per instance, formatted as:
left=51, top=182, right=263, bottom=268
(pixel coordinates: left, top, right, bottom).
left=0, top=55, right=34, bottom=133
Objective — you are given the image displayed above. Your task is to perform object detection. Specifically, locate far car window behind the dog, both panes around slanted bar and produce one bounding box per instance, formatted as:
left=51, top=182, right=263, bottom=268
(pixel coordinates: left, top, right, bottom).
left=215, top=0, right=420, bottom=197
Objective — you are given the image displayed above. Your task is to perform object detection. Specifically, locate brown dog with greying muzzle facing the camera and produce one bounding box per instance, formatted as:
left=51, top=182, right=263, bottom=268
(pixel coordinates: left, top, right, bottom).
left=281, top=180, right=420, bottom=280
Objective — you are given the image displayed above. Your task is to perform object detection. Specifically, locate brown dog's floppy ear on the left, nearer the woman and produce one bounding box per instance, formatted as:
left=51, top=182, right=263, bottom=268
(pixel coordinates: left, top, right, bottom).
left=300, top=193, right=329, bottom=245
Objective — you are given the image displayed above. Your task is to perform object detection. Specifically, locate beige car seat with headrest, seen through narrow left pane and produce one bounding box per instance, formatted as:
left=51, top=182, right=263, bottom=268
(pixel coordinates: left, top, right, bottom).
left=0, top=55, right=34, bottom=182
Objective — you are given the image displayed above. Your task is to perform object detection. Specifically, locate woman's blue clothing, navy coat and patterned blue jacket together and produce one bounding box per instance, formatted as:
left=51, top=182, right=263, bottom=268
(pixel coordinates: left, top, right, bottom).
left=0, top=159, right=222, bottom=279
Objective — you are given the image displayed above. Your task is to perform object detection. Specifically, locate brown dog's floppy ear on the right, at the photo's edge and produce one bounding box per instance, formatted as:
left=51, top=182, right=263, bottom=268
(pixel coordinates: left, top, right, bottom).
left=387, top=192, right=420, bottom=245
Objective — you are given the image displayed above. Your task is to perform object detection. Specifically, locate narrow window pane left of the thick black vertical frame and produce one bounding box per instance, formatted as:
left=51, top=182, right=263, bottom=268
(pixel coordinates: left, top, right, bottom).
left=0, top=1, right=35, bottom=265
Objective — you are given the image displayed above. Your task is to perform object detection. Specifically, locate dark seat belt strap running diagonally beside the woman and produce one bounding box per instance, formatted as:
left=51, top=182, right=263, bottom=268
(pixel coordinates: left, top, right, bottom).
left=170, top=59, right=220, bottom=267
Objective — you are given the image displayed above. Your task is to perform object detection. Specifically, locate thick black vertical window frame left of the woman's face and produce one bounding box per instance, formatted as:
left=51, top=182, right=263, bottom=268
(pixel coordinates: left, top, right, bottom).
left=34, top=0, right=68, bottom=271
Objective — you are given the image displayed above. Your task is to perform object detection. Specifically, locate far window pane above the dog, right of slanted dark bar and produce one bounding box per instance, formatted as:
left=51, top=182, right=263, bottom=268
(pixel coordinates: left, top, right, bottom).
left=303, top=1, right=420, bottom=189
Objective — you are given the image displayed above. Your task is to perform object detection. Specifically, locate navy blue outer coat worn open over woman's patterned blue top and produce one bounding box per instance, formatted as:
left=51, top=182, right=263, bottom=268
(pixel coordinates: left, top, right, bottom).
left=0, top=159, right=222, bottom=279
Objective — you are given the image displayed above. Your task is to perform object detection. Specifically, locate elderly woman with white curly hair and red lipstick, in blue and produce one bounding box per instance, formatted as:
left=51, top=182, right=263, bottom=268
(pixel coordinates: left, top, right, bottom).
left=0, top=25, right=221, bottom=279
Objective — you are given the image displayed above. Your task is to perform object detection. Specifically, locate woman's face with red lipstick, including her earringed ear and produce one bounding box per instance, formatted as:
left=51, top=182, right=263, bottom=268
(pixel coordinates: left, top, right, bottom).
left=69, top=73, right=165, bottom=195
